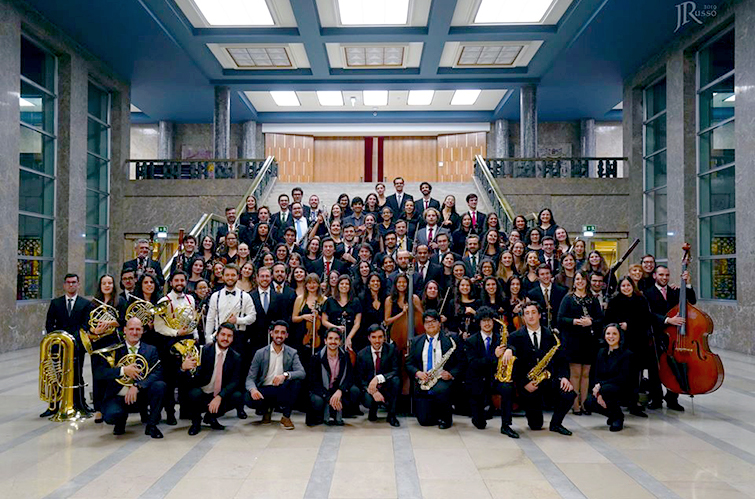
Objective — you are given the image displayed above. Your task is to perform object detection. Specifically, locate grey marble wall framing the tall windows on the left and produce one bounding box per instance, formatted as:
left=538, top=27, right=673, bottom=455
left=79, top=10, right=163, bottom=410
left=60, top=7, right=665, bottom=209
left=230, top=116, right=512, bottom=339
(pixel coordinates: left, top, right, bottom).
left=0, top=0, right=130, bottom=352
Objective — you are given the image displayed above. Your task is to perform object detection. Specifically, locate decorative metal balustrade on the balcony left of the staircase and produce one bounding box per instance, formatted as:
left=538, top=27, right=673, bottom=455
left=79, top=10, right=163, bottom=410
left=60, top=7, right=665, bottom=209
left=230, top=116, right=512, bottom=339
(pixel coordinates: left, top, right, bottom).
left=128, top=159, right=265, bottom=180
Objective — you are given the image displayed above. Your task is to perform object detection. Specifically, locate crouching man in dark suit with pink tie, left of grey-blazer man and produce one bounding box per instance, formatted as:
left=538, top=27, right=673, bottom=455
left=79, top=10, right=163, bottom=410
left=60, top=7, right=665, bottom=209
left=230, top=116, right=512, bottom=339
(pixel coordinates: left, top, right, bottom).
left=181, top=322, right=246, bottom=435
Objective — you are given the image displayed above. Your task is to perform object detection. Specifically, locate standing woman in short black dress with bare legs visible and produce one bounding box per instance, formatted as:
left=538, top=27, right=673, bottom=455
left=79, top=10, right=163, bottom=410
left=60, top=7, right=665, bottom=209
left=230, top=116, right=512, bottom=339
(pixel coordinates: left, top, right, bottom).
left=558, top=271, right=603, bottom=415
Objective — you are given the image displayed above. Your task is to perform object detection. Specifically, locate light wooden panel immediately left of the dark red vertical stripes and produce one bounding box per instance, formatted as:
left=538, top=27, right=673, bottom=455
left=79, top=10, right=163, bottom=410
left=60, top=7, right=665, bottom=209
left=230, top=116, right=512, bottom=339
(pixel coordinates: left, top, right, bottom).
left=312, top=137, right=364, bottom=182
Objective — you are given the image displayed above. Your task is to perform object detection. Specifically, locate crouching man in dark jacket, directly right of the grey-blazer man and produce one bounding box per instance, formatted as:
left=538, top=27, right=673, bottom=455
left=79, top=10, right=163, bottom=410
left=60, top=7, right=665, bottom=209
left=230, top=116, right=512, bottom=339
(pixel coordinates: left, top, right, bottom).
left=306, top=328, right=359, bottom=426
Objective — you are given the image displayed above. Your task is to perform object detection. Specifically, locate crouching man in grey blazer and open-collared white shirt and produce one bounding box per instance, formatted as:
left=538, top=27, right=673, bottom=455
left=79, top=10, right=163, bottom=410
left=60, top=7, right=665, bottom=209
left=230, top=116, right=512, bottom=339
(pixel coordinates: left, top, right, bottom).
left=244, top=320, right=306, bottom=430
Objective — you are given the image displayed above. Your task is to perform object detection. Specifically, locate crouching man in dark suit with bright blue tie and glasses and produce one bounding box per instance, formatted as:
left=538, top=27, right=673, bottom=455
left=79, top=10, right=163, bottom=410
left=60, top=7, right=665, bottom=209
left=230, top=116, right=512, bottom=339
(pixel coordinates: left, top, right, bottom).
left=406, top=310, right=464, bottom=430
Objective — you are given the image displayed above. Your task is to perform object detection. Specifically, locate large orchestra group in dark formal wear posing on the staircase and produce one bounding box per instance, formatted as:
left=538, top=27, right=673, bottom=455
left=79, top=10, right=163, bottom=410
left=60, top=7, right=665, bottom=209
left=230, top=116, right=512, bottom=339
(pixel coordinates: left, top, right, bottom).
left=42, top=178, right=695, bottom=438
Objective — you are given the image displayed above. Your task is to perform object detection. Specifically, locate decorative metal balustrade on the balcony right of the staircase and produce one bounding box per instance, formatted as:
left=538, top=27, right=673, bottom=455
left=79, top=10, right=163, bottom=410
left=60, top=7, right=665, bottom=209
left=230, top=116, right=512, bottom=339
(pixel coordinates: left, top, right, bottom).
left=485, top=157, right=628, bottom=178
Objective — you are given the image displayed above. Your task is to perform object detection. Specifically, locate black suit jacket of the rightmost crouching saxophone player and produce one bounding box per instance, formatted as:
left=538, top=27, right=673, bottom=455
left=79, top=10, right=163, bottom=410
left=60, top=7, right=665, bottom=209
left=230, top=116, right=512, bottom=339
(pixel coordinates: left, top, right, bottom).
left=508, top=326, right=569, bottom=387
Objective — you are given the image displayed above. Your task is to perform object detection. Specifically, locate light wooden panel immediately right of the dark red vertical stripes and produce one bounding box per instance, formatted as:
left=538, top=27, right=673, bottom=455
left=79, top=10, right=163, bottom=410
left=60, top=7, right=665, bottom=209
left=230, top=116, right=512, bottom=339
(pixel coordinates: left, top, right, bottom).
left=383, top=137, right=438, bottom=182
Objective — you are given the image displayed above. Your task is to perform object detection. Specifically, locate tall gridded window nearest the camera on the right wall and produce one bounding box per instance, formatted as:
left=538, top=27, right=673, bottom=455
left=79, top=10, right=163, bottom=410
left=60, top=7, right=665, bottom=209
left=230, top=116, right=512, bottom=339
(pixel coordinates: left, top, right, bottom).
left=697, top=30, right=737, bottom=300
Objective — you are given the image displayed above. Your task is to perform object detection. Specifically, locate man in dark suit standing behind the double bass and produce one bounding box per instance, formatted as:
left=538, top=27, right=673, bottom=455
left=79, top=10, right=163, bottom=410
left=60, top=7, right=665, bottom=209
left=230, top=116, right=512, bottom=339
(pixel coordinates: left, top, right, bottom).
left=645, top=265, right=697, bottom=411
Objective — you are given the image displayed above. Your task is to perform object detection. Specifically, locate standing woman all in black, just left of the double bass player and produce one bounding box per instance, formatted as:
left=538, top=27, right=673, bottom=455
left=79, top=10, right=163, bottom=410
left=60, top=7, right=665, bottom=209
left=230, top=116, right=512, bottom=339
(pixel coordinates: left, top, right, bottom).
left=606, top=276, right=657, bottom=417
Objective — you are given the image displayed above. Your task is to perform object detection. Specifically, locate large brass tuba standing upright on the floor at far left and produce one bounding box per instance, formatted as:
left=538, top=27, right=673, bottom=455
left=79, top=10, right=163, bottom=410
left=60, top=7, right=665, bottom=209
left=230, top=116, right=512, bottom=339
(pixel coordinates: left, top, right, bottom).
left=39, top=331, right=89, bottom=422
